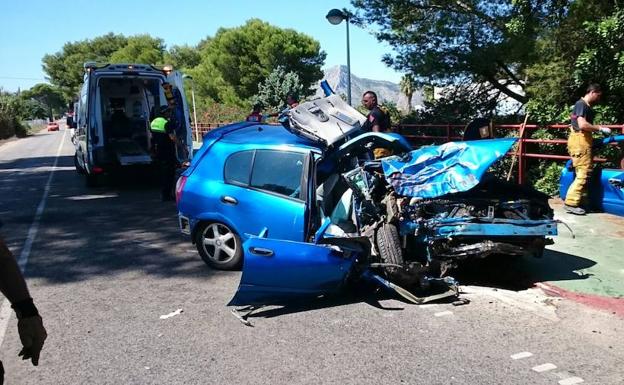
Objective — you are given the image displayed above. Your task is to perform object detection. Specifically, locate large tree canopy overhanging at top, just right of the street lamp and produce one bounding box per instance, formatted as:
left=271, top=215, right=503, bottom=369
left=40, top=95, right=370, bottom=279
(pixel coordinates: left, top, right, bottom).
left=352, top=0, right=568, bottom=103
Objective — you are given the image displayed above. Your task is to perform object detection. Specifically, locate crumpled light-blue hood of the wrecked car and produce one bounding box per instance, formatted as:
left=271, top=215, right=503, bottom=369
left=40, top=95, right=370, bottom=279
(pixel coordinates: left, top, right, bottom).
left=381, top=138, right=516, bottom=198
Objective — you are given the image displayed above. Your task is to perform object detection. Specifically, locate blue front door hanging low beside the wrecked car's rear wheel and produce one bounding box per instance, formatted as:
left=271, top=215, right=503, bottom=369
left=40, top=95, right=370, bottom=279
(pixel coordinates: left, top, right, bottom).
left=228, top=237, right=354, bottom=306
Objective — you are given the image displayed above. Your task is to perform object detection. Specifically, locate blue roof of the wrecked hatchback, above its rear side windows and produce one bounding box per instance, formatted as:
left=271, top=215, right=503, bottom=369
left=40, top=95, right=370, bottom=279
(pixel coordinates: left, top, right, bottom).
left=221, top=123, right=321, bottom=150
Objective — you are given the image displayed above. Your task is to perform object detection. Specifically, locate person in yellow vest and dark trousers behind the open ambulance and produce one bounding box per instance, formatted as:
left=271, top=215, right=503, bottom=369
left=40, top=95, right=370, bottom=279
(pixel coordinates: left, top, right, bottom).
left=150, top=107, right=178, bottom=201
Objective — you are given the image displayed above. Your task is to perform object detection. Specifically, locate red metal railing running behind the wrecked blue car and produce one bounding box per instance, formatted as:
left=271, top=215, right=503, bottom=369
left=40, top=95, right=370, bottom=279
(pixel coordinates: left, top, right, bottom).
left=193, top=123, right=624, bottom=184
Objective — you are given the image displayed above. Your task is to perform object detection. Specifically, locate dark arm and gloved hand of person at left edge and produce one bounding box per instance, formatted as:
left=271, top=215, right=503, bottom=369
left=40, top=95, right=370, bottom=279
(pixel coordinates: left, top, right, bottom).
left=0, top=222, right=48, bottom=384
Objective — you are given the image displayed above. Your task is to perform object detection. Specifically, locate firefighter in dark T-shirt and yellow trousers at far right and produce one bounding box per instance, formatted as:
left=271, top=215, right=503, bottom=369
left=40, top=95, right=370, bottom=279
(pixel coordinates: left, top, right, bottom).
left=564, top=84, right=611, bottom=215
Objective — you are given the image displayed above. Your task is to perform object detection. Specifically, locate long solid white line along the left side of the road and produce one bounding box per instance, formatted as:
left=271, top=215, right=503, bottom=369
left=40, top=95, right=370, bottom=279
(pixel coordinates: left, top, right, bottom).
left=0, top=130, right=67, bottom=347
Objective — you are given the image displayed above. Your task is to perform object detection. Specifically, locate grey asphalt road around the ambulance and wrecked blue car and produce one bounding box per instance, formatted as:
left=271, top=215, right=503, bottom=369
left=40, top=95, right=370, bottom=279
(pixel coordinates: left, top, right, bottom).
left=0, top=124, right=624, bottom=385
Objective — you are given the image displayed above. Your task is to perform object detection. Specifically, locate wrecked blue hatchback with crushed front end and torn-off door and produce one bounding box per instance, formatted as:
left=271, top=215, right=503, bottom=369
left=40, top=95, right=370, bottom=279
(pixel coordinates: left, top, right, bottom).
left=178, top=95, right=557, bottom=306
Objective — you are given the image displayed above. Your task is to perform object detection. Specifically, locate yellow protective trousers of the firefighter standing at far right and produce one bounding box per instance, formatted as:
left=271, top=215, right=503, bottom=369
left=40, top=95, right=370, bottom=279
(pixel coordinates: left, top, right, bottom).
left=565, top=130, right=593, bottom=207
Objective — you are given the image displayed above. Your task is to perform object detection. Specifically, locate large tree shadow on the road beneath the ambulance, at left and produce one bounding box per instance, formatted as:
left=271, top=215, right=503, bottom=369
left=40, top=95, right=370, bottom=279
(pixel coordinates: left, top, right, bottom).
left=0, top=156, right=218, bottom=283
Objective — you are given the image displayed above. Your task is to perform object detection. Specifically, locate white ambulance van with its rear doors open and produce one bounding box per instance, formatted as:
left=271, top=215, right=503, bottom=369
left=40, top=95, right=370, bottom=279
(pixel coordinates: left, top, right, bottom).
left=74, top=63, right=193, bottom=186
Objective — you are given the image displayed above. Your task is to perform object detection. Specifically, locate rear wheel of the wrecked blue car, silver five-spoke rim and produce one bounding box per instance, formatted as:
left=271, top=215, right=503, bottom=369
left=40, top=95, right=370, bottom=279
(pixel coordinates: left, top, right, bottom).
left=195, top=222, right=243, bottom=270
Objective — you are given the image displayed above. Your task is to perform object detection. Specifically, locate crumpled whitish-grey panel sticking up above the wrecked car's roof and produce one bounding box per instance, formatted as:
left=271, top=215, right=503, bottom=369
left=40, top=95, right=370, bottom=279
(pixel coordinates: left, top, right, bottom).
left=284, top=95, right=366, bottom=147
